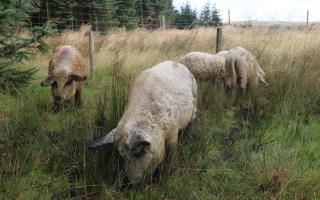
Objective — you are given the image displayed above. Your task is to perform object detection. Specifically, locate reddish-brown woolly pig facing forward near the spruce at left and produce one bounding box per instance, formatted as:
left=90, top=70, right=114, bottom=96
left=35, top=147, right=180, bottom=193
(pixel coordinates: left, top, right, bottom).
left=41, top=46, right=87, bottom=108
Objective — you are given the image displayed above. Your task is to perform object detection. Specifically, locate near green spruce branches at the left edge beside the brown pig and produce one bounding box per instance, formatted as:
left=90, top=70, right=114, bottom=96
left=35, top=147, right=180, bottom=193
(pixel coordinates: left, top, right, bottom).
left=0, top=0, right=53, bottom=91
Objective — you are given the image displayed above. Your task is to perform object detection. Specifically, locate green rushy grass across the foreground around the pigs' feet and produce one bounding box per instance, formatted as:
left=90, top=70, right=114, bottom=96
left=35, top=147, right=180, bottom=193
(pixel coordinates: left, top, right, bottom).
left=0, top=28, right=320, bottom=200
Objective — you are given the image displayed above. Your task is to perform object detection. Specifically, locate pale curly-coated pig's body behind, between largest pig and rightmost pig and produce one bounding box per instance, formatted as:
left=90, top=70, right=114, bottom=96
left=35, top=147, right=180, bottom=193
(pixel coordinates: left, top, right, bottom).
left=179, top=52, right=225, bottom=80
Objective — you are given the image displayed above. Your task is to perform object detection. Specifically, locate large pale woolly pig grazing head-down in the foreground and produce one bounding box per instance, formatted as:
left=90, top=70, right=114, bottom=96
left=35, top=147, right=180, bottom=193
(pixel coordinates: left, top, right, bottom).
left=91, top=61, right=197, bottom=184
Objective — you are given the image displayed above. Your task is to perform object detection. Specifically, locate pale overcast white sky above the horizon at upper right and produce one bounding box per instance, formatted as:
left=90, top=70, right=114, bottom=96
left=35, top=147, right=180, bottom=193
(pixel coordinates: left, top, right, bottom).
left=173, top=0, right=320, bottom=22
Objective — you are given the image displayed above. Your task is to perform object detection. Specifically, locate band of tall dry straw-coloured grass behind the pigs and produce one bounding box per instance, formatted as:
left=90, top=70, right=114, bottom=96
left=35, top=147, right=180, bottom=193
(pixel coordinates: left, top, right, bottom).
left=33, top=26, right=320, bottom=76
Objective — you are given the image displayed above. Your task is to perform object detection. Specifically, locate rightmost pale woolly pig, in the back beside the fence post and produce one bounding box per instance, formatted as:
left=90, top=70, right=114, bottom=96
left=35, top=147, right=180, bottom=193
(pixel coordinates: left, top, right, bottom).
left=217, top=47, right=267, bottom=89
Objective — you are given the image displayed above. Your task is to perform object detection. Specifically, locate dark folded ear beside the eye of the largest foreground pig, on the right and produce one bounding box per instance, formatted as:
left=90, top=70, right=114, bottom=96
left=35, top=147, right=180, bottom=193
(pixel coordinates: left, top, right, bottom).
left=126, top=130, right=151, bottom=150
